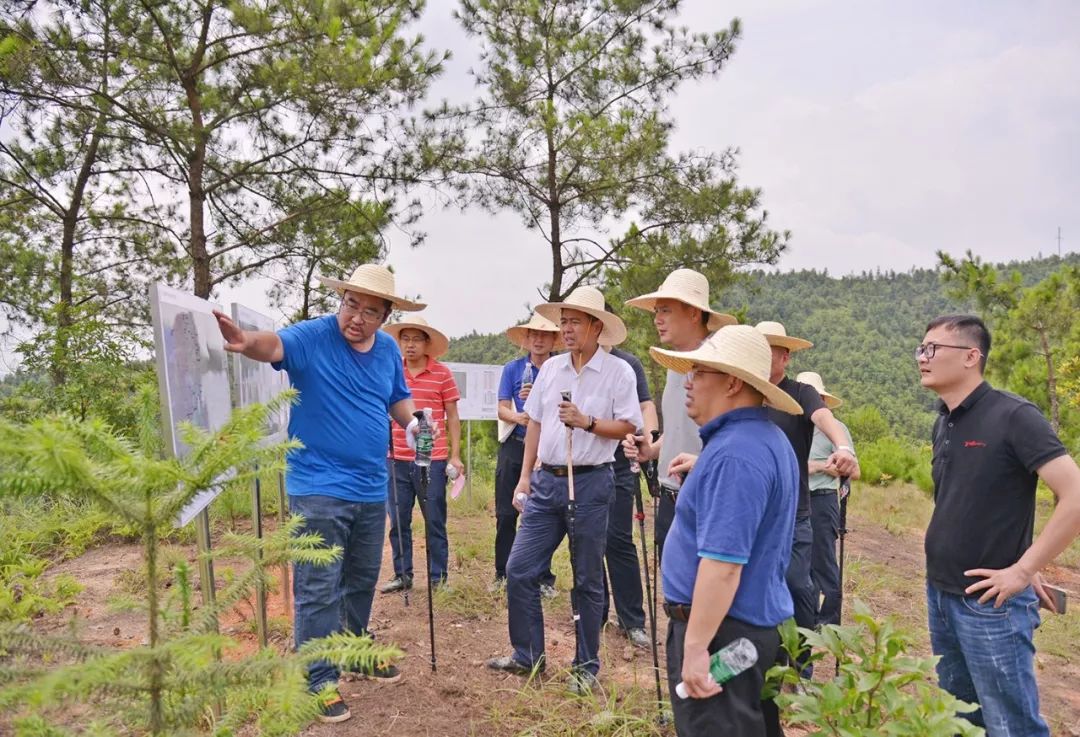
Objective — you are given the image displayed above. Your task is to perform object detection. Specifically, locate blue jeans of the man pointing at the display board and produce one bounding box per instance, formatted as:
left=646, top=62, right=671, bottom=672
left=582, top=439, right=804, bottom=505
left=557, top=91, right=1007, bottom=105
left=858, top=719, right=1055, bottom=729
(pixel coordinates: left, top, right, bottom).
left=288, top=495, right=387, bottom=692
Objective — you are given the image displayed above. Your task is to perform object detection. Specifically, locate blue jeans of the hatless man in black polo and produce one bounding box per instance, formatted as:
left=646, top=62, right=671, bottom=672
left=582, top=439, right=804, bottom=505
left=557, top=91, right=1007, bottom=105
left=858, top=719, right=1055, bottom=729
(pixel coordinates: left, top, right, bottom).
left=927, top=582, right=1050, bottom=737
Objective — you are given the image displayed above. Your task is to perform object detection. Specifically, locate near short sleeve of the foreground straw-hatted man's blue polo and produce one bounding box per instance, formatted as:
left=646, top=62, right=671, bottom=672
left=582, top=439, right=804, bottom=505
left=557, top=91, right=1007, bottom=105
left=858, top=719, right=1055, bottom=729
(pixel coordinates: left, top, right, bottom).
left=694, top=457, right=769, bottom=565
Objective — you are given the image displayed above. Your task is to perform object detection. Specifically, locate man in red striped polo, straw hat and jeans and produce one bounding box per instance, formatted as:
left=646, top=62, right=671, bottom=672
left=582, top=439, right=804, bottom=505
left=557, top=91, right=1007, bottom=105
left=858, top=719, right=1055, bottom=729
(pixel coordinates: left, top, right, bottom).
left=380, top=317, right=464, bottom=593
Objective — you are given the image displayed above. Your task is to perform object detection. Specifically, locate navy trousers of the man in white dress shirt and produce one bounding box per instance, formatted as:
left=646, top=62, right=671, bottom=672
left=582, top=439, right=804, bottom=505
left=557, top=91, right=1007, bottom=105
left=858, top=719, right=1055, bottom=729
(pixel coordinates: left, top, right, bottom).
left=507, top=467, right=615, bottom=674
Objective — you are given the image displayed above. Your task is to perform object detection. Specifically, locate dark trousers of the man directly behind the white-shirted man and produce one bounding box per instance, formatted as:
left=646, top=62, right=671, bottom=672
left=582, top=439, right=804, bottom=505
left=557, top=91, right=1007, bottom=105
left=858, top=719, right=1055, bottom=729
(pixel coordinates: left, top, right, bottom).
left=602, top=464, right=647, bottom=630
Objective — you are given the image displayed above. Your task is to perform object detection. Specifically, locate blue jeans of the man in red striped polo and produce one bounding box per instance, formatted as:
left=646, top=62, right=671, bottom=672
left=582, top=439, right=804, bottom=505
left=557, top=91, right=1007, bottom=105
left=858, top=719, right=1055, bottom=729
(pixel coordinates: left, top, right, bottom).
left=387, top=460, right=450, bottom=581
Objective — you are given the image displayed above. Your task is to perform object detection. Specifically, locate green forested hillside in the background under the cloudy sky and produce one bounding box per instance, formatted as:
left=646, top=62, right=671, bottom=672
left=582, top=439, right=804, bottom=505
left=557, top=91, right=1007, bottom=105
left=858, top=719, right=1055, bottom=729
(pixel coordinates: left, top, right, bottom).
left=446, top=254, right=1080, bottom=441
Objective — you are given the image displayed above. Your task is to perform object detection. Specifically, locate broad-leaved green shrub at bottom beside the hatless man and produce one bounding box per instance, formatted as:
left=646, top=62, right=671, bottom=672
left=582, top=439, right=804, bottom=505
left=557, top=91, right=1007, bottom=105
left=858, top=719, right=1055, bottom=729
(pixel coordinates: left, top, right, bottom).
left=766, top=602, right=985, bottom=737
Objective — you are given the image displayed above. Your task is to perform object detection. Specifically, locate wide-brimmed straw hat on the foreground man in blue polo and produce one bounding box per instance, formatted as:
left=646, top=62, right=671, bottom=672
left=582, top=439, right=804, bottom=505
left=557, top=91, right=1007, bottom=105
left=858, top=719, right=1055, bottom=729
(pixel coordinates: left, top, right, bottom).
left=649, top=325, right=802, bottom=415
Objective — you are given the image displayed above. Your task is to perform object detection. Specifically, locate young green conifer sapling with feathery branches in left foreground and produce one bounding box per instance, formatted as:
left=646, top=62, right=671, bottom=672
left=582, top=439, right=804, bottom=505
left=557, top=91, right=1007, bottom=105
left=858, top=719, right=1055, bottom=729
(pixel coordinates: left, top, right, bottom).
left=0, top=394, right=401, bottom=737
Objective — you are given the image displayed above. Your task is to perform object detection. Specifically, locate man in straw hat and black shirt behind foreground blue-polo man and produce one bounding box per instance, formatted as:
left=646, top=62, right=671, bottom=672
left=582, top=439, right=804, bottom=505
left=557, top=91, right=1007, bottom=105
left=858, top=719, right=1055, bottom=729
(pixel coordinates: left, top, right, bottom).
left=757, top=322, right=859, bottom=678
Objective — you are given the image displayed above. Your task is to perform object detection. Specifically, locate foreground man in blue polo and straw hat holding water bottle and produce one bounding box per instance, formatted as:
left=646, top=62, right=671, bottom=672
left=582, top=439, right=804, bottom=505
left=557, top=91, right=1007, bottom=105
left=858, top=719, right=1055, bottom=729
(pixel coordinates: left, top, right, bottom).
left=649, top=325, right=801, bottom=737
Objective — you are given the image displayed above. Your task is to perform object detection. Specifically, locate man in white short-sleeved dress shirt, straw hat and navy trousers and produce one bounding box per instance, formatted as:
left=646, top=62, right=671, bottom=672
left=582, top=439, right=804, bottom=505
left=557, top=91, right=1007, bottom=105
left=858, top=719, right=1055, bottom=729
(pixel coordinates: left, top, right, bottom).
left=487, top=286, right=643, bottom=694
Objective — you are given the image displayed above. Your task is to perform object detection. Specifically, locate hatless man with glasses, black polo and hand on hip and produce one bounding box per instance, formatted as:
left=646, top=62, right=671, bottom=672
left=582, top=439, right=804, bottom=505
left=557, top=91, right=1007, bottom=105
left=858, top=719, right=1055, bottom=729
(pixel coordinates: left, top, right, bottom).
left=915, top=314, right=1080, bottom=737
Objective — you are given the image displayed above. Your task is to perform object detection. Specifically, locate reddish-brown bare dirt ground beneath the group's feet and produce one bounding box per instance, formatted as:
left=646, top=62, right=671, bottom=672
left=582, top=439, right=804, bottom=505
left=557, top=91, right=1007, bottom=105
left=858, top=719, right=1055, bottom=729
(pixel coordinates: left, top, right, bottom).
left=39, top=490, right=1080, bottom=737
